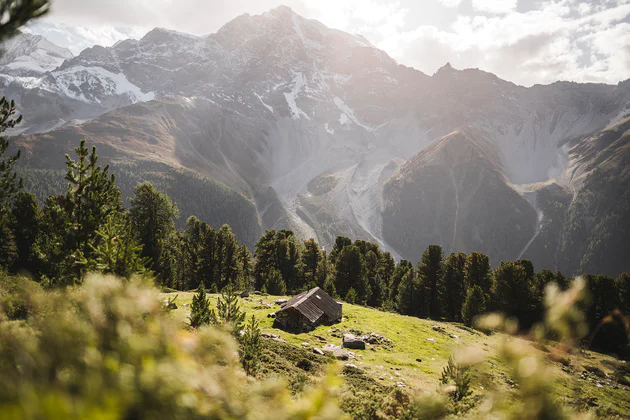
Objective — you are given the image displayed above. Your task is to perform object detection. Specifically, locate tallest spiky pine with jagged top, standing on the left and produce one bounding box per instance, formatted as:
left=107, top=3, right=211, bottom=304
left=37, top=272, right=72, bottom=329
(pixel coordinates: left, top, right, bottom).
left=65, top=140, right=121, bottom=259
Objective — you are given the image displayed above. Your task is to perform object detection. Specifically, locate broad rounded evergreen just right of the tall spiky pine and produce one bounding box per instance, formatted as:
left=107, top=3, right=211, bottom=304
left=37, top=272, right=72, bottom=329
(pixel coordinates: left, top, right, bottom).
left=130, top=182, right=179, bottom=268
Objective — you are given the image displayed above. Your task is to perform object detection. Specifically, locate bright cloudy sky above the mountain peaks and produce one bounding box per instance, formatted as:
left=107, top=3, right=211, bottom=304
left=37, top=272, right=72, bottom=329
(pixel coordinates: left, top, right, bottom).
left=22, top=0, right=630, bottom=86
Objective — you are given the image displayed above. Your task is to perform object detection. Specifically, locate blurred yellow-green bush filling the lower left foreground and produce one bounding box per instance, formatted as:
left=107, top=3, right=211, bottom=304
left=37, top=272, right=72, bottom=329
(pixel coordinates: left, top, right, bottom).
left=0, top=274, right=341, bottom=420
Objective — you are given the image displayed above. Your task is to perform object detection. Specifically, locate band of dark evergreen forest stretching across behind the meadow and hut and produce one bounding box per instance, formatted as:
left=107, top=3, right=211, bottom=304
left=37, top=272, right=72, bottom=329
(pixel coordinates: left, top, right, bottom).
left=0, top=130, right=630, bottom=354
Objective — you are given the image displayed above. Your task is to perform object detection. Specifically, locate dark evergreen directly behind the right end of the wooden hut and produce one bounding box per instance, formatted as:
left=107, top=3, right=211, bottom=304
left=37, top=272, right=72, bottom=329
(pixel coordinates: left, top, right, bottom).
left=335, top=245, right=371, bottom=304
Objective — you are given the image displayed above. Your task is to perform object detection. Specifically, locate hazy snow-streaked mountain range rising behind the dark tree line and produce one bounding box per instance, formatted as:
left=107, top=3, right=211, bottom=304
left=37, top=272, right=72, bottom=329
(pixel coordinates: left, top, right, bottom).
left=0, top=6, right=630, bottom=274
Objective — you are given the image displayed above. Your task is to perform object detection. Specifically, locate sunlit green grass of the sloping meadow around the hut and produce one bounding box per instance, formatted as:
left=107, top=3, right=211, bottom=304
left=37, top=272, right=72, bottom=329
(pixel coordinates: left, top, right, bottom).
left=162, top=292, right=630, bottom=418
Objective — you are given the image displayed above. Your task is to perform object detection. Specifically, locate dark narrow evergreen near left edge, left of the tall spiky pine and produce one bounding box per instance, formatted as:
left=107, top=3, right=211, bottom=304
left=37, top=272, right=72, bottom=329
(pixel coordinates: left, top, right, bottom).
left=12, top=191, right=42, bottom=270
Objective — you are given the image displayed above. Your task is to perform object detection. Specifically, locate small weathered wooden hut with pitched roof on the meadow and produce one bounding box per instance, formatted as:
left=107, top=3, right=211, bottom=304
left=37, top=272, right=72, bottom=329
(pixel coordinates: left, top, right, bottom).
left=275, top=287, right=341, bottom=331
